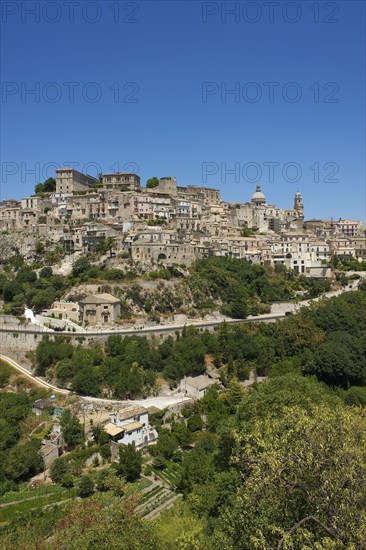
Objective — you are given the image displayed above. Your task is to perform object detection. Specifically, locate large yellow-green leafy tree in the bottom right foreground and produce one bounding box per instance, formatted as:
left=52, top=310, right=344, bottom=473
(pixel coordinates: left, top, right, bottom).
left=214, top=405, right=366, bottom=550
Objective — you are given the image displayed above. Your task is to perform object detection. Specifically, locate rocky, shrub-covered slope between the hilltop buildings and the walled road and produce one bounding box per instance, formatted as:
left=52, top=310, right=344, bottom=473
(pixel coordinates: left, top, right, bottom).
left=0, top=255, right=330, bottom=320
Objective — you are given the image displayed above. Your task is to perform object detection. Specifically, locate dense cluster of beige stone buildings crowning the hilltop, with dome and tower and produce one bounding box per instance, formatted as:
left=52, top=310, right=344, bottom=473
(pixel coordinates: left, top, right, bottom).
left=0, top=168, right=366, bottom=277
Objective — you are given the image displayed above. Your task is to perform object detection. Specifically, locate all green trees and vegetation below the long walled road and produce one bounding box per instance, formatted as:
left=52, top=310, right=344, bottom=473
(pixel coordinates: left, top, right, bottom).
left=0, top=290, right=366, bottom=550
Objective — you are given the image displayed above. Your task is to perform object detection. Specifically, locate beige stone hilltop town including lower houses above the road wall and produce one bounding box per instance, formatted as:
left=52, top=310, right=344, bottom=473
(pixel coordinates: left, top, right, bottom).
left=0, top=168, right=366, bottom=326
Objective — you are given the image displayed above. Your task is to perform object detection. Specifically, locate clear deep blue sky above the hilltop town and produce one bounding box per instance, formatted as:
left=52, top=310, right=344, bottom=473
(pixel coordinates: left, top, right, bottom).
left=1, top=0, right=365, bottom=219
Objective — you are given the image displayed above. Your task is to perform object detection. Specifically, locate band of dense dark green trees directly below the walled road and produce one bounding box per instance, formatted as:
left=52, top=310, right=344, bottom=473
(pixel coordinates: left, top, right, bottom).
left=35, top=291, right=366, bottom=399
